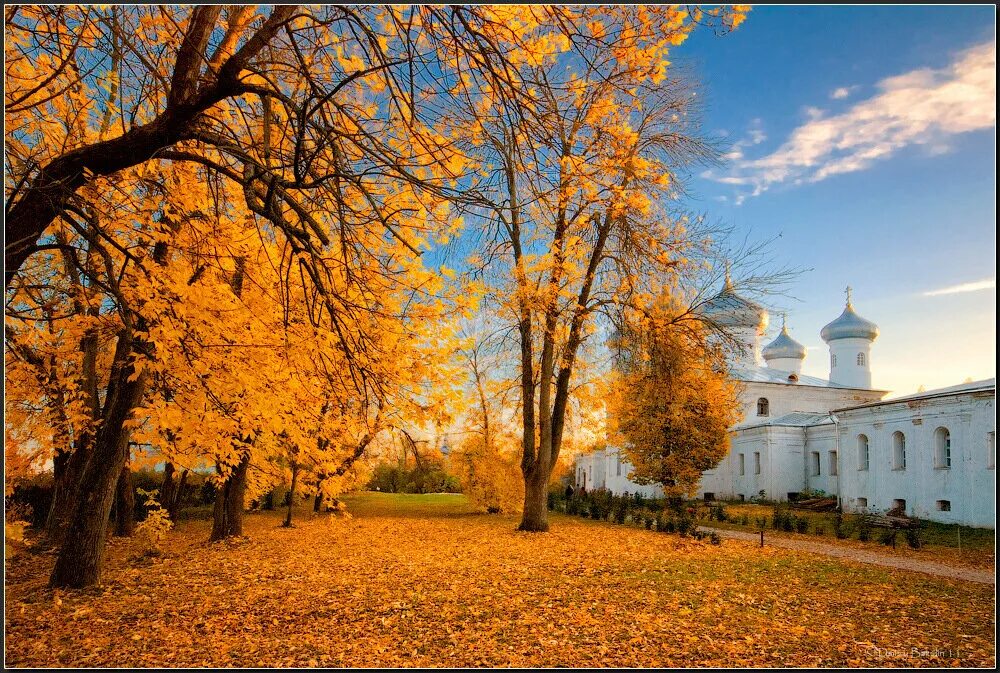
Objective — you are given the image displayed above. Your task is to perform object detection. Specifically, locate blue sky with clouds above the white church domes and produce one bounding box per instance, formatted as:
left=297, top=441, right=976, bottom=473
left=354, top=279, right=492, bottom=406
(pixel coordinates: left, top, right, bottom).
left=672, top=6, right=996, bottom=394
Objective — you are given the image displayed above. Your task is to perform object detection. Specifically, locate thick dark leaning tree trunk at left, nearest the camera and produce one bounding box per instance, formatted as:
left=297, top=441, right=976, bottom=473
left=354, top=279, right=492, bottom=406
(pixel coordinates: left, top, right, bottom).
left=49, top=333, right=146, bottom=588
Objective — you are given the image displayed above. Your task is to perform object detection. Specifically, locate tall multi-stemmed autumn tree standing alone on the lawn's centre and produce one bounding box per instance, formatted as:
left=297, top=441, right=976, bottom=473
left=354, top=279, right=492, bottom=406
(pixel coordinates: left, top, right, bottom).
left=455, top=6, right=744, bottom=531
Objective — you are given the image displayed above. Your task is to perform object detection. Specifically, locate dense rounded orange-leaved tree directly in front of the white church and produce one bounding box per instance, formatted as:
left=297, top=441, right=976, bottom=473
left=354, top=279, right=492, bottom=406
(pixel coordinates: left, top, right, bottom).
left=608, top=300, right=740, bottom=497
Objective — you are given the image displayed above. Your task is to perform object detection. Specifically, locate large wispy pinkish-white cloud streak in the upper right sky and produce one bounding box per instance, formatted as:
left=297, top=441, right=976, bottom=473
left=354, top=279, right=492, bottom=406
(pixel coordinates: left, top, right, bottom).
left=703, top=41, right=996, bottom=203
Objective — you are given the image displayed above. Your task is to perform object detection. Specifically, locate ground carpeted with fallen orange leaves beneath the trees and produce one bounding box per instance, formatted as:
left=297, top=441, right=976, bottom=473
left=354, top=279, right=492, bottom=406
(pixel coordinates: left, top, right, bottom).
left=5, top=494, right=995, bottom=667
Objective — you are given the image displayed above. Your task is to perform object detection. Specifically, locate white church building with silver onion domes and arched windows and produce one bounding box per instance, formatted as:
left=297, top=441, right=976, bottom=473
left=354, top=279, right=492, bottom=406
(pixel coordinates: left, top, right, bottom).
left=575, top=277, right=996, bottom=528
